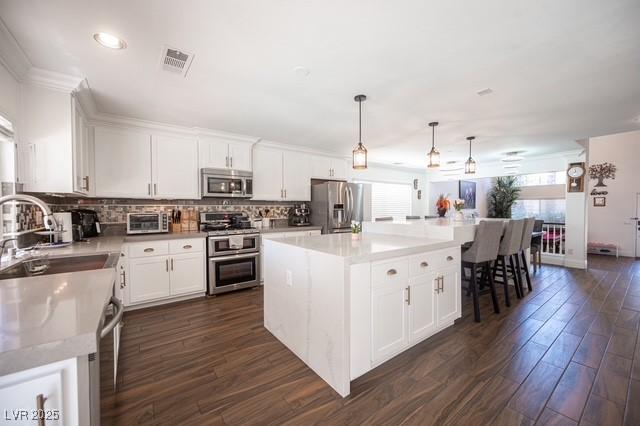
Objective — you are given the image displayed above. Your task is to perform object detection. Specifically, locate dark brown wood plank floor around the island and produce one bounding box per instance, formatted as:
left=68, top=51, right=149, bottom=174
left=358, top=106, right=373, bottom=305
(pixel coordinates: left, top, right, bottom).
left=102, top=256, right=640, bottom=425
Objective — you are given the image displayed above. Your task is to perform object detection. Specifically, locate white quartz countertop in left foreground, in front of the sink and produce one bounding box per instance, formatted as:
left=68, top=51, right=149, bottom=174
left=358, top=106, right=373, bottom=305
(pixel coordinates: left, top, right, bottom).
left=0, top=268, right=116, bottom=375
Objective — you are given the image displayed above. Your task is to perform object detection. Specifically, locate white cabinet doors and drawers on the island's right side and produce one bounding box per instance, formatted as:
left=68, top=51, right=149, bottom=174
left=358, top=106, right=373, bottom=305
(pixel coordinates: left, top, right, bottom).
left=368, top=249, right=461, bottom=365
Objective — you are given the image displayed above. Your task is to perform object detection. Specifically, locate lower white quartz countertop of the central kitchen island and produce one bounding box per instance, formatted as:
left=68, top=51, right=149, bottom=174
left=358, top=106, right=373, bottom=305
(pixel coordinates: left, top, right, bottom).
left=265, top=233, right=459, bottom=264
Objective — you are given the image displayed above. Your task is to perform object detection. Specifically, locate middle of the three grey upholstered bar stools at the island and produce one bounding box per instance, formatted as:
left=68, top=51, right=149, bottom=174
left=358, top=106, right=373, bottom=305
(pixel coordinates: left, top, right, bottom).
left=493, top=219, right=524, bottom=306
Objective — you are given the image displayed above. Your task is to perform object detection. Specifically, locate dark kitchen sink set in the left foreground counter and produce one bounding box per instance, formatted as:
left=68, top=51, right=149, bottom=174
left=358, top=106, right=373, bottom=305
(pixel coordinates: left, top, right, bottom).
left=0, top=254, right=118, bottom=280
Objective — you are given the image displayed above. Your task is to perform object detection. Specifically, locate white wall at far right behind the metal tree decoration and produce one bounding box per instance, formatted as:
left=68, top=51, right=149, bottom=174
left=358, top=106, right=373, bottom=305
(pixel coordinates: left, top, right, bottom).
left=588, top=131, right=640, bottom=256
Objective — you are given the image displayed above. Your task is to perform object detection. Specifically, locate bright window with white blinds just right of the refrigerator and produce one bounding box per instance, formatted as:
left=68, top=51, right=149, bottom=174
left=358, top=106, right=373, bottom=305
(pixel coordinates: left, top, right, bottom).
left=360, top=182, right=412, bottom=220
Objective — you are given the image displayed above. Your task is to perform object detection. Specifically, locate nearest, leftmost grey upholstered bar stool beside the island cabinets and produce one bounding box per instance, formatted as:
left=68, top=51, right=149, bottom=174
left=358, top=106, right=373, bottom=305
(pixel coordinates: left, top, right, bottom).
left=462, top=220, right=502, bottom=322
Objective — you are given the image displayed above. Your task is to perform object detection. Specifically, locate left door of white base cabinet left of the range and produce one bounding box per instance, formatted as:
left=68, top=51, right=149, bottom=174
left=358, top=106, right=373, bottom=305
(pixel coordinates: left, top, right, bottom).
left=129, top=256, right=171, bottom=304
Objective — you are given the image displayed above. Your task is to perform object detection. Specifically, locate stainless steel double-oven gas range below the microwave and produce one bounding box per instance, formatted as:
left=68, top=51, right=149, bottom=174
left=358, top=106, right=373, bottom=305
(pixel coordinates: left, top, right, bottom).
left=200, top=213, right=260, bottom=295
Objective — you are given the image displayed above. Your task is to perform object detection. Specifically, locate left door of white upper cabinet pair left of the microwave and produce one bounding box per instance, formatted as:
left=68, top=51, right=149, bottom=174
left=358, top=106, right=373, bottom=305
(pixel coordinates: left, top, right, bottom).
left=95, top=127, right=153, bottom=198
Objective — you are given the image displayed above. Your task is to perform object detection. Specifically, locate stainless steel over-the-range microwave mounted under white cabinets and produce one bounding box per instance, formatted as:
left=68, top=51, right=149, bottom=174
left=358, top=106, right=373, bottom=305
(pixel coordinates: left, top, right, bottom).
left=200, top=169, right=253, bottom=198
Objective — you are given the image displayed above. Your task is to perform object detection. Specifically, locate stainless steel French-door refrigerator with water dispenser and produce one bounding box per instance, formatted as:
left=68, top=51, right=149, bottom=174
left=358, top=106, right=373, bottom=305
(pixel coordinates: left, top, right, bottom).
left=311, top=181, right=364, bottom=234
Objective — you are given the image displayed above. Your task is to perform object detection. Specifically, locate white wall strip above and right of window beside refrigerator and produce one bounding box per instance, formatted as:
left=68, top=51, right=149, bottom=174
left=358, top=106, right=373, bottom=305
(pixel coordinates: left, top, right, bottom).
left=349, top=164, right=428, bottom=216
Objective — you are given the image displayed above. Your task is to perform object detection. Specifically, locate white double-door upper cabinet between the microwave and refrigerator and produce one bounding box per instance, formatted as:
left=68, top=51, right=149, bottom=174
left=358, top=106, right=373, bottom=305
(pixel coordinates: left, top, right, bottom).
left=253, top=147, right=311, bottom=201
